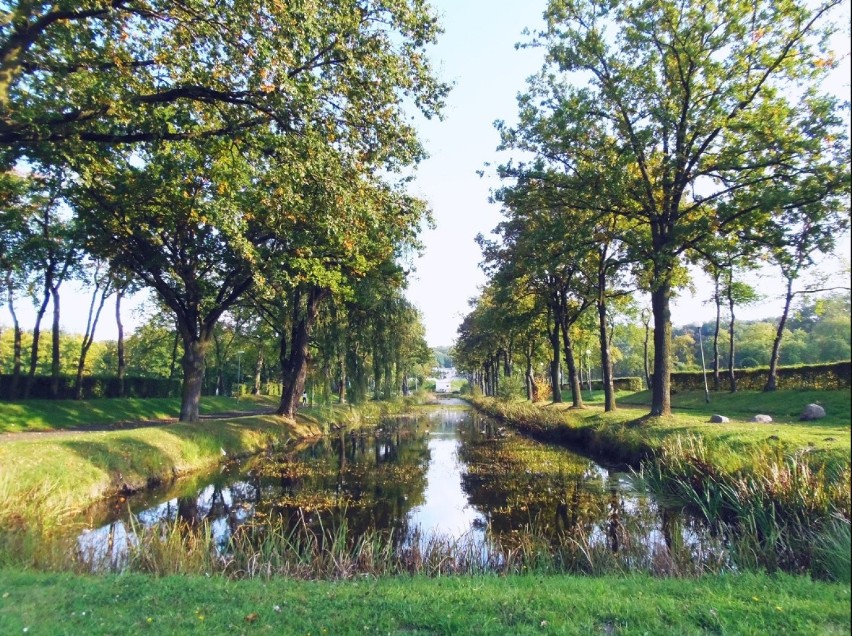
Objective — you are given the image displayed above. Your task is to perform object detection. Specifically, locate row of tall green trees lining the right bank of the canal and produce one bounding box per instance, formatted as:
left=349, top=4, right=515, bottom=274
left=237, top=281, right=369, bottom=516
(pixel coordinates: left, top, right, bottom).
left=457, top=0, right=850, bottom=415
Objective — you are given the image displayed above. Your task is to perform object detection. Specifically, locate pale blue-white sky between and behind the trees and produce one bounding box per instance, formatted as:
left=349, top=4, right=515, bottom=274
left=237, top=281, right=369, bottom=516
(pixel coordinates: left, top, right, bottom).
left=0, top=0, right=850, bottom=347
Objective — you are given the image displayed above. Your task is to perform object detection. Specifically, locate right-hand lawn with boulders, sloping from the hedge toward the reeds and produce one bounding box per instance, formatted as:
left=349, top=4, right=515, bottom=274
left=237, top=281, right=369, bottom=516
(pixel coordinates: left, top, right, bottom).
left=474, top=389, right=852, bottom=472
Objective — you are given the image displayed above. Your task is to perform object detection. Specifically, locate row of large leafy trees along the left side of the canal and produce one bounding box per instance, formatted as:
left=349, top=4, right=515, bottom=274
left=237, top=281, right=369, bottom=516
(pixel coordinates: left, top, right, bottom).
left=0, top=0, right=447, bottom=421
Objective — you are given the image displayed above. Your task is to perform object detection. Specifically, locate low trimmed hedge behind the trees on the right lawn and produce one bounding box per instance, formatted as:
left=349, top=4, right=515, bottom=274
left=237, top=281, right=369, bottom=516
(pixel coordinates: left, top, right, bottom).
left=671, top=360, right=852, bottom=391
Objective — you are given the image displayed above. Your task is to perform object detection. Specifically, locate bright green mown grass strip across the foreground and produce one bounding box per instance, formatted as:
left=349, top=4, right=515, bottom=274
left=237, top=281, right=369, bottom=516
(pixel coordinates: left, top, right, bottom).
left=0, top=571, right=850, bottom=635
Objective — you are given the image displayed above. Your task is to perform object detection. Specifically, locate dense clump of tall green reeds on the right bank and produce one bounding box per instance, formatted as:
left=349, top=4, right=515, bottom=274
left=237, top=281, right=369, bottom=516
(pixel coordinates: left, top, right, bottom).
left=637, top=436, right=850, bottom=580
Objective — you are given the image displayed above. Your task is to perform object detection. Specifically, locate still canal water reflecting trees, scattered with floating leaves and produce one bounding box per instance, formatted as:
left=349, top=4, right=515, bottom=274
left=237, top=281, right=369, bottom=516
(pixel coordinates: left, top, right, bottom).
left=77, top=408, right=717, bottom=568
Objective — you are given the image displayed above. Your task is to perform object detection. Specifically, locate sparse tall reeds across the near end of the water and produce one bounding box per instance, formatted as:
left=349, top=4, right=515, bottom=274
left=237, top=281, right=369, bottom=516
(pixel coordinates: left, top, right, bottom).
left=10, top=504, right=729, bottom=579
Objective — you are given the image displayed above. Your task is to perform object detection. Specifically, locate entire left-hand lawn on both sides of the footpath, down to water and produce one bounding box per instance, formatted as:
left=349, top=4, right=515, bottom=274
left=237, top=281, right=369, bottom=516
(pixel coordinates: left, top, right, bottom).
left=0, top=397, right=440, bottom=527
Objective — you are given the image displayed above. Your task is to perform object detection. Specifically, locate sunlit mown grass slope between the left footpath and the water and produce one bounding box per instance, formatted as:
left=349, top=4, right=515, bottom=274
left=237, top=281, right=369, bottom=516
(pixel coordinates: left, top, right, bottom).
left=0, top=415, right=320, bottom=526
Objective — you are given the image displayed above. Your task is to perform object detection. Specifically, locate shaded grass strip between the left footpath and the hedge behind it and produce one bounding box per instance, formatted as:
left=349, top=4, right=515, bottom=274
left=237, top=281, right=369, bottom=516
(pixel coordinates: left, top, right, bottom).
left=0, top=396, right=278, bottom=433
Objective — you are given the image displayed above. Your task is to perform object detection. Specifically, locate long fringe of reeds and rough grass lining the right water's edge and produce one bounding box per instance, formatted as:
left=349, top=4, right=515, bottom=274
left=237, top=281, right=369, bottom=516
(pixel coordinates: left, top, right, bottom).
left=471, top=398, right=852, bottom=583
